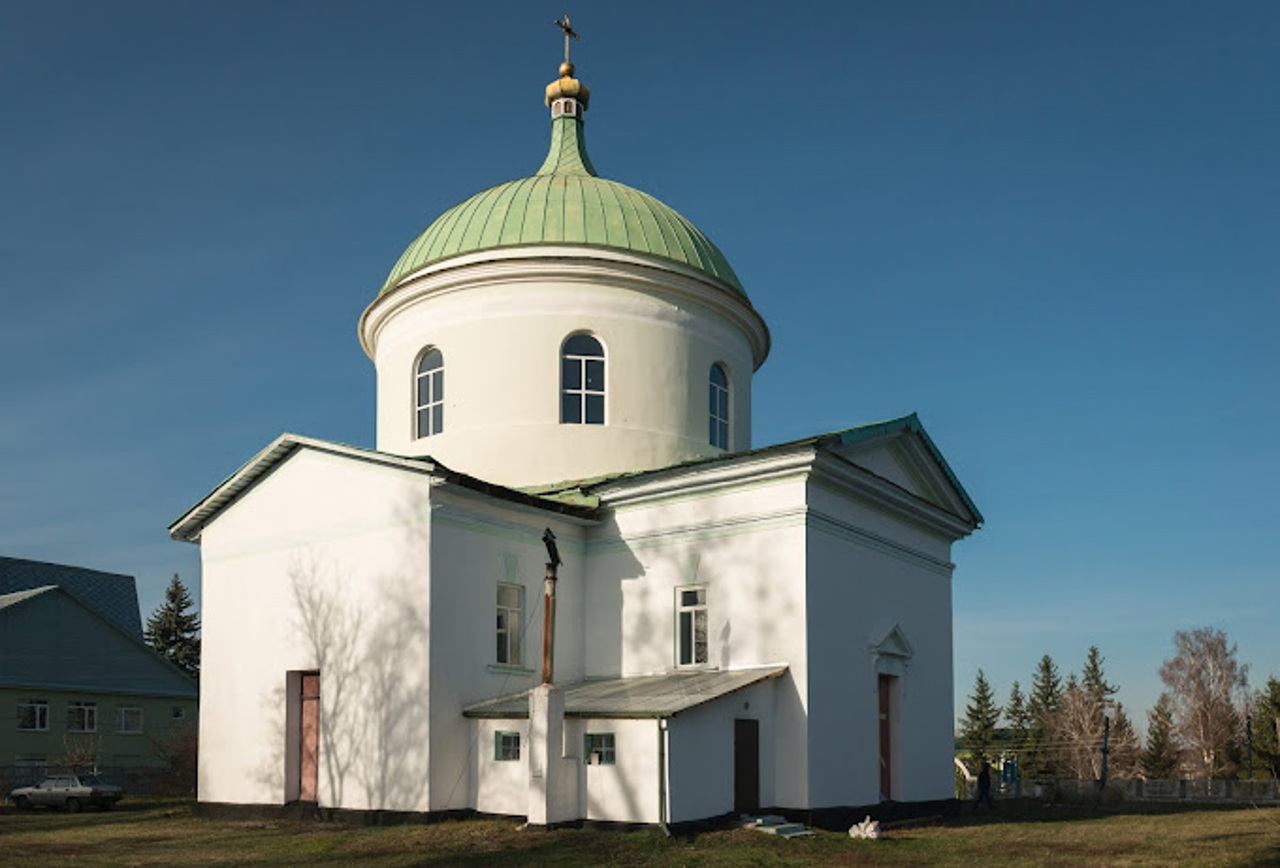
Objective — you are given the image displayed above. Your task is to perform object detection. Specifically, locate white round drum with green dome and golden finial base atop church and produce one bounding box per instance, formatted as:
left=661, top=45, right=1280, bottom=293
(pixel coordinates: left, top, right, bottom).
left=360, top=63, right=769, bottom=486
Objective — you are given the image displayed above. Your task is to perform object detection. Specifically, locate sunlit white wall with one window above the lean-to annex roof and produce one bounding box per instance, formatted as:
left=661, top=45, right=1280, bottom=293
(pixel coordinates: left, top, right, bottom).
left=585, top=474, right=809, bottom=808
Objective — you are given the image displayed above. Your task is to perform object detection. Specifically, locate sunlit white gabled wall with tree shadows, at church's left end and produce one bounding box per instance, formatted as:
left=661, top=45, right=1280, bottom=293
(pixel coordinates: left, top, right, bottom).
left=200, top=449, right=430, bottom=810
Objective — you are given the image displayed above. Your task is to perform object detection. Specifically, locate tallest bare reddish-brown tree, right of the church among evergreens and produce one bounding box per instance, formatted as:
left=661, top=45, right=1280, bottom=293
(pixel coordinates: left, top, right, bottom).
left=1160, top=627, right=1249, bottom=777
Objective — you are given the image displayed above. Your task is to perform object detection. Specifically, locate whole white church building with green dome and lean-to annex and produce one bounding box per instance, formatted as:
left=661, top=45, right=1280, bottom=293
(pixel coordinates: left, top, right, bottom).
left=170, top=49, right=982, bottom=824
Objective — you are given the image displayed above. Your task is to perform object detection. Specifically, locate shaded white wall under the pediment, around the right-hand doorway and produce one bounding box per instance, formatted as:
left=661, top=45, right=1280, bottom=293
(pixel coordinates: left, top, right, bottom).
left=806, top=485, right=954, bottom=807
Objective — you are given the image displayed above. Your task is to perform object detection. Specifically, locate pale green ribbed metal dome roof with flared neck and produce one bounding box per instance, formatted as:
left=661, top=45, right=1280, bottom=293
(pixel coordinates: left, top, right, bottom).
left=379, top=115, right=746, bottom=298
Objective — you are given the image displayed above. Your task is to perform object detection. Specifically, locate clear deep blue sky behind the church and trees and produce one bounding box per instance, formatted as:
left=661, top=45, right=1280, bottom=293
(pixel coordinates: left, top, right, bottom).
left=0, top=0, right=1280, bottom=732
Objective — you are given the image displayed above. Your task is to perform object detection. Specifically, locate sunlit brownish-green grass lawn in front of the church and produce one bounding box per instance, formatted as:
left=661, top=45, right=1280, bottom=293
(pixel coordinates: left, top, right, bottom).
left=0, top=799, right=1280, bottom=868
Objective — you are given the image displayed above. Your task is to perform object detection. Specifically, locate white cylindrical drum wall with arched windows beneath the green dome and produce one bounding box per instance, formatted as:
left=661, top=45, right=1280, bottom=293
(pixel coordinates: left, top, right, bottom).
left=366, top=250, right=767, bottom=486
